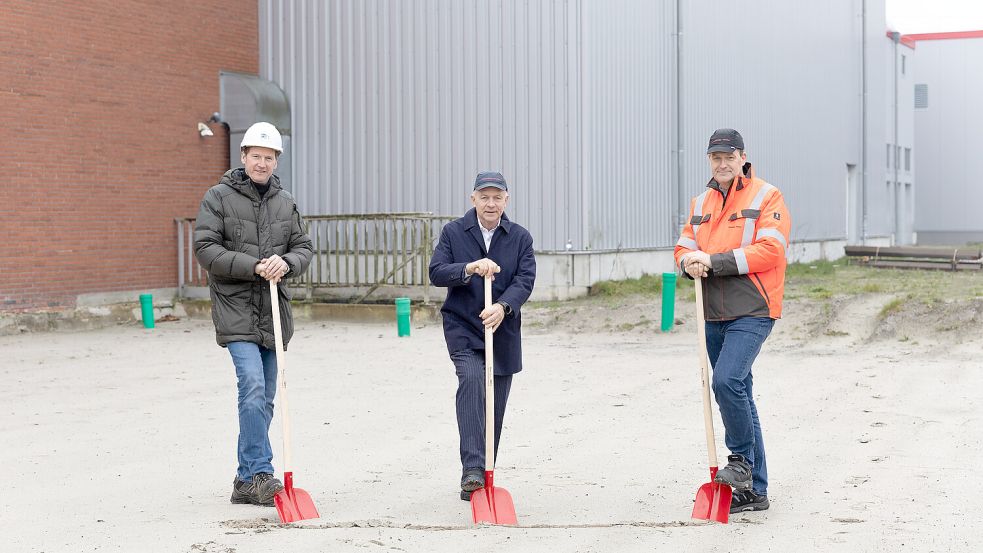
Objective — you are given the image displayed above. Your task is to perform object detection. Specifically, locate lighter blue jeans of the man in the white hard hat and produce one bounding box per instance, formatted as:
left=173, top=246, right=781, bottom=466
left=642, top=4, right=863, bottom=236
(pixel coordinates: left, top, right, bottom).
left=228, top=342, right=276, bottom=482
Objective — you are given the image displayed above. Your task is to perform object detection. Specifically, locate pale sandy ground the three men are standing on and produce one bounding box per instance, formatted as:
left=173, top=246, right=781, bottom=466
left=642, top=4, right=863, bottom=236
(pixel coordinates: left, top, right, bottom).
left=0, top=300, right=983, bottom=553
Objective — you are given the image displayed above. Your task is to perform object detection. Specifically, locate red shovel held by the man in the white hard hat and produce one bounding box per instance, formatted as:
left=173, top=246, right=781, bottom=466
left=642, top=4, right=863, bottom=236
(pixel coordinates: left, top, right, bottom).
left=270, top=280, right=321, bottom=522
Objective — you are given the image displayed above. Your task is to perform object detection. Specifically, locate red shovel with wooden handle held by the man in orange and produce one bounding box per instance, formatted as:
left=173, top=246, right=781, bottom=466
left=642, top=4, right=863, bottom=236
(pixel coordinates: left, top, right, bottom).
left=692, top=277, right=733, bottom=524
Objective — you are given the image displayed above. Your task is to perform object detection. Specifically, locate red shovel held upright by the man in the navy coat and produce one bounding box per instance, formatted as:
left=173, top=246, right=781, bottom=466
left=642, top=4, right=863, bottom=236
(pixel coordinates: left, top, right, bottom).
left=471, top=275, right=518, bottom=525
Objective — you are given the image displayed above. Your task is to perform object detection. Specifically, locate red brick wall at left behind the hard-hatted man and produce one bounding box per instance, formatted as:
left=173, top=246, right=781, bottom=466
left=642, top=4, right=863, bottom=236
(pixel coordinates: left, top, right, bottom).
left=0, top=0, right=259, bottom=312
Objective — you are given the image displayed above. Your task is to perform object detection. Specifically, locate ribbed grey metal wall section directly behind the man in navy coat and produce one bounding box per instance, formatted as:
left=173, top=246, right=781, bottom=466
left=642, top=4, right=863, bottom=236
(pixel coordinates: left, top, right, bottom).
left=260, top=0, right=583, bottom=249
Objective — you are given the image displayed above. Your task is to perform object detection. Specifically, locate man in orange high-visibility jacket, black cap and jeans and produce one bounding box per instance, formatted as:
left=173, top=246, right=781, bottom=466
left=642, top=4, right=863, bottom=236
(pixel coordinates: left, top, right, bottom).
left=675, top=129, right=791, bottom=513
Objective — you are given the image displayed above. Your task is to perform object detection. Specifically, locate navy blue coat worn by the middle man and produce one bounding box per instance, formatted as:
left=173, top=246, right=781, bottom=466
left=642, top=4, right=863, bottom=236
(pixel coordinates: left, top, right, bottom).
left=430, top=208, right=536, bottom=375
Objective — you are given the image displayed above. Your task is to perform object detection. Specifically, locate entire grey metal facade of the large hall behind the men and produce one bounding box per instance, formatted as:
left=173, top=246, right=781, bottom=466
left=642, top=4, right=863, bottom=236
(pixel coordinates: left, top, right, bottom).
left=259, top=0, right=893, bottom=250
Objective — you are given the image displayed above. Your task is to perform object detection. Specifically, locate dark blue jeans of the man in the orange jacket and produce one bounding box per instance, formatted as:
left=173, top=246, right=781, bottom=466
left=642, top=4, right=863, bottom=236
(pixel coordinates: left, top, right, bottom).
left=706, top=317, right=775, bottom=495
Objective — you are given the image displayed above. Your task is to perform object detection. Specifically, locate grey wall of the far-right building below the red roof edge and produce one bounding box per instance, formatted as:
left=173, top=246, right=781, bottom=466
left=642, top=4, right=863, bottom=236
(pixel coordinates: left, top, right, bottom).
left=914, top=36, right=983, bottom=244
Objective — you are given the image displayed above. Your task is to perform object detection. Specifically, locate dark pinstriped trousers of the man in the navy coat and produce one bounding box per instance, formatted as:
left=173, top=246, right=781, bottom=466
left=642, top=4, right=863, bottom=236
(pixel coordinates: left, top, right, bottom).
left=451, top=349, right=512, bottom=470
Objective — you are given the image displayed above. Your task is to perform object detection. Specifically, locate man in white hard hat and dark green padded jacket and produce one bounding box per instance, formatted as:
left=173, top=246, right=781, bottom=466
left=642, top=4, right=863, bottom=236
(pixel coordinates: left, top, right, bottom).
left=194, top=123, right=313, bottom=506
